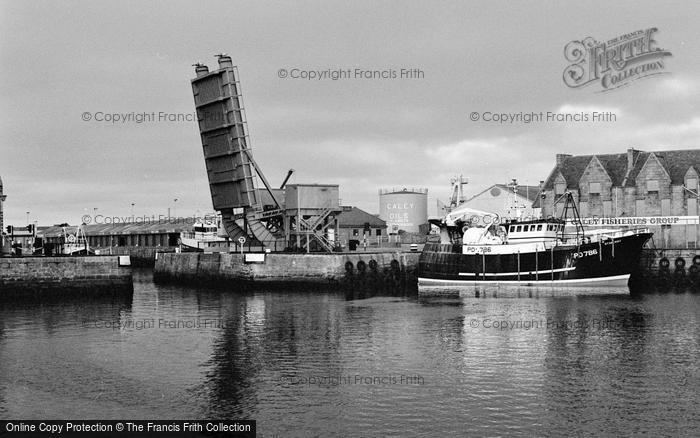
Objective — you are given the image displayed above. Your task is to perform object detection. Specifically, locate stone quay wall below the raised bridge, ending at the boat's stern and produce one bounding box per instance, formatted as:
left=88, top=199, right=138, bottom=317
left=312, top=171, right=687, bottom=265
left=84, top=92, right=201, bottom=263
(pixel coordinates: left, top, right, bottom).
left=153, top=252, right=419, bottom=288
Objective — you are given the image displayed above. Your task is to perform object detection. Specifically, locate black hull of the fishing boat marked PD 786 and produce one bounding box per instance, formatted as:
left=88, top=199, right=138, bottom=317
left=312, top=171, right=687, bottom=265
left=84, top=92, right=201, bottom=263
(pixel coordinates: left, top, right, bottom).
left=418, top=233, right=651, bottom=287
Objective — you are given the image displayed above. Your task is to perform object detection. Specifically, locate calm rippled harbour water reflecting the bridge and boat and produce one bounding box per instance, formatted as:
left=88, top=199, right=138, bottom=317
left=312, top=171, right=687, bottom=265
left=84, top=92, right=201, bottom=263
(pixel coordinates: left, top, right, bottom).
left=0, top=271, right=700, bottom=436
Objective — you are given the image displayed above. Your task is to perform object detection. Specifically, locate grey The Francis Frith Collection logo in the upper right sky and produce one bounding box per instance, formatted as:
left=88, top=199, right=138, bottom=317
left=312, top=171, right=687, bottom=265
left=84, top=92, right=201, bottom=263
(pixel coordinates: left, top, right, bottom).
left=564, top=27, right=671, bottom=92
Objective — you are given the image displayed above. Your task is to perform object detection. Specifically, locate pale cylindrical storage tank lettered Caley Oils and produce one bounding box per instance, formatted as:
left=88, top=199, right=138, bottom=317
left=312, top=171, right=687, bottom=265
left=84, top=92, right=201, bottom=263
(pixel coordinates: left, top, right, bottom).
left=379, top=188, right=428, bottom=234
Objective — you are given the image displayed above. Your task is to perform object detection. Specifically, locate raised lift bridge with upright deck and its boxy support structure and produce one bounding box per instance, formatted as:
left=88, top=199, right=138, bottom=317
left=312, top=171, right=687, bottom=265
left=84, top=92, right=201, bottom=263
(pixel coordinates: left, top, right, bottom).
left=192, top=54, right=341, bottom=251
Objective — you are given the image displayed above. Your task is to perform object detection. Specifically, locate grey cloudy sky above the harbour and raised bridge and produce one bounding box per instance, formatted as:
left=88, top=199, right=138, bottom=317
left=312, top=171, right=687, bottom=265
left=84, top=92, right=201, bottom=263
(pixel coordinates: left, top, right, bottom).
left=0, top=0, right=700, bottom=225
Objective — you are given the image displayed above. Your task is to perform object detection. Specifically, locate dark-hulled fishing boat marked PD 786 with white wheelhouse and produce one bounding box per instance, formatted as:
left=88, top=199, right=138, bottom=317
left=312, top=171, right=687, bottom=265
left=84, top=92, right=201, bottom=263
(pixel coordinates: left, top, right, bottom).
left=418, top=192, right=652, bottom=289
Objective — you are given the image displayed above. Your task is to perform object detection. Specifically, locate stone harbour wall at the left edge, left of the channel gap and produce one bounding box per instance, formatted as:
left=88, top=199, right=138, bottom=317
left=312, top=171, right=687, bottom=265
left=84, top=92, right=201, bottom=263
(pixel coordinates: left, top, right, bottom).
left=0, top=256, right=133, bottom=301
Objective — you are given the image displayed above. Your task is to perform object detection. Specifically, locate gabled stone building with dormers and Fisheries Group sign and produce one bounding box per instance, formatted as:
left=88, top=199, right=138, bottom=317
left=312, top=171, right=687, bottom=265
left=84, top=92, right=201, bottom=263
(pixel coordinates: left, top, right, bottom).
left=533, top=149, right=700, bottom=248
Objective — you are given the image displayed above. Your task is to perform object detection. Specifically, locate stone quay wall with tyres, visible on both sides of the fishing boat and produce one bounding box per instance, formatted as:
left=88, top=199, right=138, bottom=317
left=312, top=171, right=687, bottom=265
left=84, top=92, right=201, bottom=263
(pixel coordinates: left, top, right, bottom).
left=154, top=249, right=700, bottom=289
